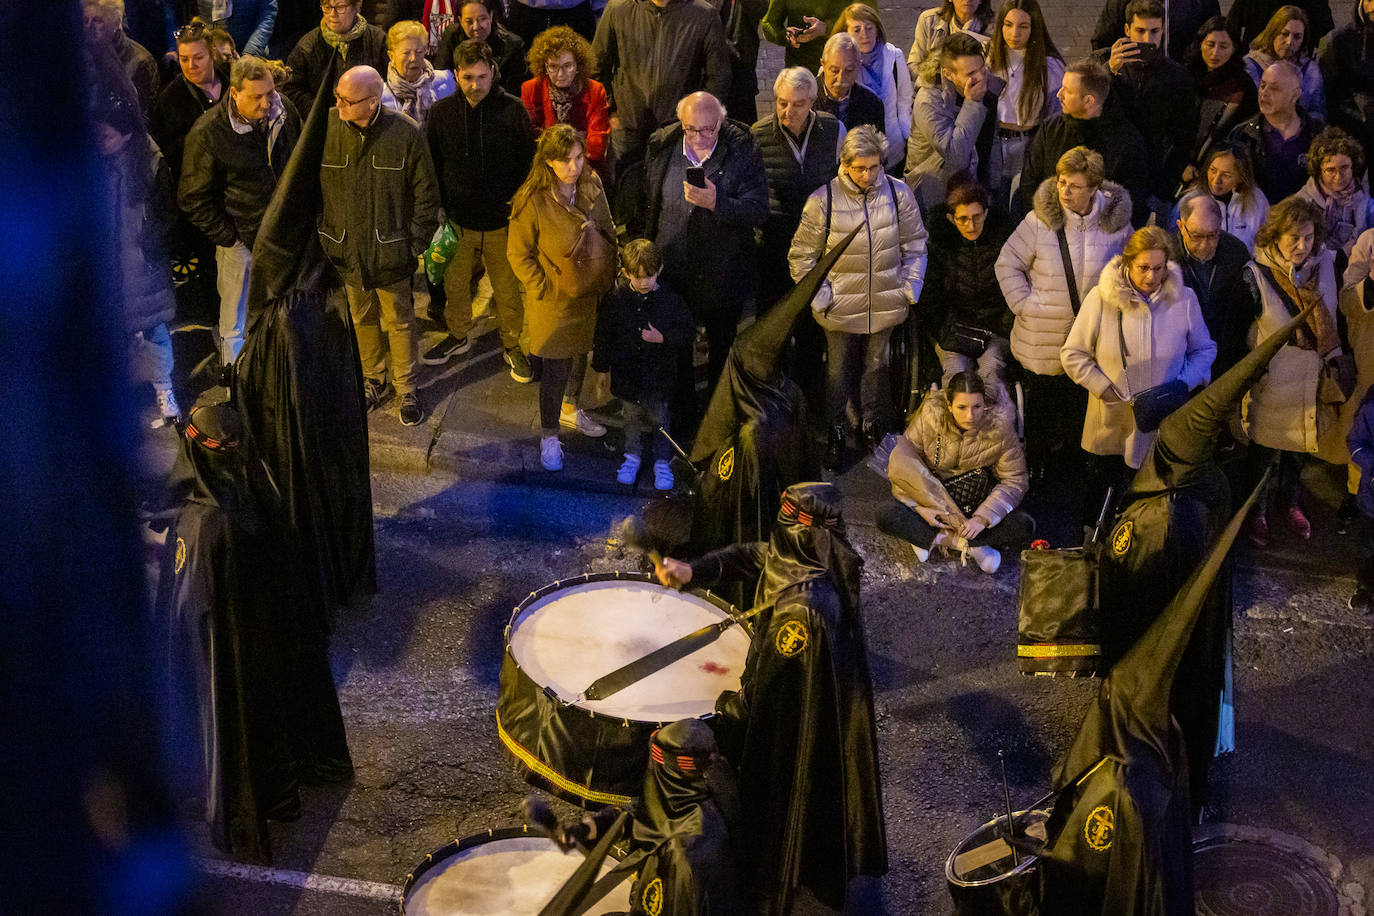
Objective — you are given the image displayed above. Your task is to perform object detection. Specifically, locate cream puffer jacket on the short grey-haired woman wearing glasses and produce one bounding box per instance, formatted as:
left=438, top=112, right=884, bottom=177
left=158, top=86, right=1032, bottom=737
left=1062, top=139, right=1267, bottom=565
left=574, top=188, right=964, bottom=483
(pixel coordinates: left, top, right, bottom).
left=787, top=166, right=926, bottom=334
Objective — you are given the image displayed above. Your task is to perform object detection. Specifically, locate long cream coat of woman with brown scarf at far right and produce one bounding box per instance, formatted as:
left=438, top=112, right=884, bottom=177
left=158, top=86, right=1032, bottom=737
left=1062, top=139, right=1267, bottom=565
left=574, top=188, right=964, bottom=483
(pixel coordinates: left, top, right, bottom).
left=1241, top=249, right=1344, bottom=460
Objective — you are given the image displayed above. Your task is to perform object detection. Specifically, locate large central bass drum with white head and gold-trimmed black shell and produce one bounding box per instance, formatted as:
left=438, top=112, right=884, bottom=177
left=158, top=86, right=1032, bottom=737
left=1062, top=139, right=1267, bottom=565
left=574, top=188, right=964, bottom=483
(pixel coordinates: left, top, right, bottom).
left=496, top=573, right=750, bottom=805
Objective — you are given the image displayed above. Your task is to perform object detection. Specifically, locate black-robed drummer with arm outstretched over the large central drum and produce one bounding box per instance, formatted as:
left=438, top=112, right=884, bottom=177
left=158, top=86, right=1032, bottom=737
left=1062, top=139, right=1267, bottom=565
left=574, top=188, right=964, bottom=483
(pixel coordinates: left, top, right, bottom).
left=692, top=483, right=888, bottom=913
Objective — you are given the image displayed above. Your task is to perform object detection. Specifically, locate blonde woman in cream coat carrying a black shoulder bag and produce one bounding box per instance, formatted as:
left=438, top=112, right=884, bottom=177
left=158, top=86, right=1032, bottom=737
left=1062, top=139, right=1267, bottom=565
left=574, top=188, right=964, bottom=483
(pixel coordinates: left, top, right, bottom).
left=1059, top=225, right=1216, bottom=505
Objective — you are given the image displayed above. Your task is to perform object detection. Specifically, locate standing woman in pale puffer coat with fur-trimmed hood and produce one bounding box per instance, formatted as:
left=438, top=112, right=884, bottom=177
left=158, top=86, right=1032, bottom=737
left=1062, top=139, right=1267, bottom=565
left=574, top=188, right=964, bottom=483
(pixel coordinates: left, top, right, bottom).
left=996, top=147, right=1131, bottom=468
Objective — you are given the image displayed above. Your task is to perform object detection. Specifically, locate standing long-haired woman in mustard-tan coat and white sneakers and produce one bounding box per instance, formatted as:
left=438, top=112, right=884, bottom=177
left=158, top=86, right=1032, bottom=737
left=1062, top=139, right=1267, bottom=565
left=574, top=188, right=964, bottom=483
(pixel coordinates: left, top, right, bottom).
left=506, top=124, right=616, bottom=471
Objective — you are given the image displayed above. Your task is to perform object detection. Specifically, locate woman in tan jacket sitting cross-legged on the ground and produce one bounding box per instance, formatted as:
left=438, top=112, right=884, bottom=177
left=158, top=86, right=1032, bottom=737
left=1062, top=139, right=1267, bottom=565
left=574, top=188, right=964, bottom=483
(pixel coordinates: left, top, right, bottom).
left=878, top=372, right=1035, bottom=573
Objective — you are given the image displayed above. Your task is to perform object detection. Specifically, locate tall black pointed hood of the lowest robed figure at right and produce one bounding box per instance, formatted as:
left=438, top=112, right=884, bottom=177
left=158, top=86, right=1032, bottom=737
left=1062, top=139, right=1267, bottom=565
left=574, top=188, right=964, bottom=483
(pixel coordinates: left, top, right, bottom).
left=1055, top=472, right=1268, bottom=790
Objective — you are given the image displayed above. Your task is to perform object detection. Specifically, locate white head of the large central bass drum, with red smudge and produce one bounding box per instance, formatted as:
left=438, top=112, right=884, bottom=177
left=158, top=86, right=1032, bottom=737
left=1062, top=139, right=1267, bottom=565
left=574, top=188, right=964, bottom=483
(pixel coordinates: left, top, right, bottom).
left=510, top=580, right=749, bottom=722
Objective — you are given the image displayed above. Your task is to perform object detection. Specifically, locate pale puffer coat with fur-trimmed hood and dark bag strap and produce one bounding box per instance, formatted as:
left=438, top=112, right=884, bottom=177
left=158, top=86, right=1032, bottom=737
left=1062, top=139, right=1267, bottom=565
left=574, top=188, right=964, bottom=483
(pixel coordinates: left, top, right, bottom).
left=996, top=177, right=1131, bottom=375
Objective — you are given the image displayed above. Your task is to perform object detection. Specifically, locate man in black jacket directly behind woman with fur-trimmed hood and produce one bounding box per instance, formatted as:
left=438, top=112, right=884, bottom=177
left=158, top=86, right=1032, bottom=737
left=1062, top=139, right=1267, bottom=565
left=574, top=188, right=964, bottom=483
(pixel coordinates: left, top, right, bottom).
left=1017, top=60, right=1148, bottom=225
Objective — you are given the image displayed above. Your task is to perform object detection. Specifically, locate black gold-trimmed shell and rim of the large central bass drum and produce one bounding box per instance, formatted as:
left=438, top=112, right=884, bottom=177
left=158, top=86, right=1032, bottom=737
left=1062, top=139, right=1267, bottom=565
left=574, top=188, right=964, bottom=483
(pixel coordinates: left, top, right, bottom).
left=496, top=574, right=750, bottom=806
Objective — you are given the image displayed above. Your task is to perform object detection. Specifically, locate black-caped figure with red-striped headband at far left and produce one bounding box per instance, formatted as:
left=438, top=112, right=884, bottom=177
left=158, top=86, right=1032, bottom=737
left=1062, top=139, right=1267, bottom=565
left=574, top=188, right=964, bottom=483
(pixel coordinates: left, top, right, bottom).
left=159, top=404, right=348, bottom=862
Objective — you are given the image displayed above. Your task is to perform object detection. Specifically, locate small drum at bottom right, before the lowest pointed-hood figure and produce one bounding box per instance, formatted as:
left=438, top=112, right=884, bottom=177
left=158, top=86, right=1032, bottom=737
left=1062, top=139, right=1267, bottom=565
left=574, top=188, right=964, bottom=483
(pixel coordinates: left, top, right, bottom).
left=945, top=810, right=1052, bottom=916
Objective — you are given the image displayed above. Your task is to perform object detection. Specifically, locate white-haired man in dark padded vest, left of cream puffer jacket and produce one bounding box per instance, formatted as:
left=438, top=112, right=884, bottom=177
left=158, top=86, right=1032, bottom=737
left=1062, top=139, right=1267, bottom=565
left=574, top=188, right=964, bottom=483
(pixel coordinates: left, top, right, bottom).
left=749, top=67, right=844, bottom=309
